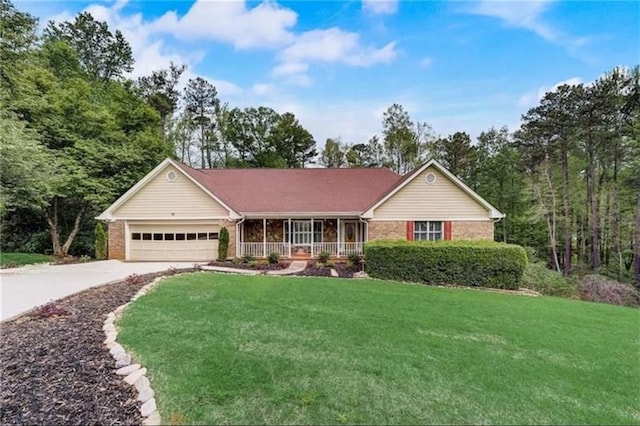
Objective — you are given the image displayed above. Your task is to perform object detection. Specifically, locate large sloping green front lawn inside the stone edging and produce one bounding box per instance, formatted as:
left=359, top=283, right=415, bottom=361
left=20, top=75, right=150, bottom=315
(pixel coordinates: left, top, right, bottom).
left=118, top=273, right=640, bottom=424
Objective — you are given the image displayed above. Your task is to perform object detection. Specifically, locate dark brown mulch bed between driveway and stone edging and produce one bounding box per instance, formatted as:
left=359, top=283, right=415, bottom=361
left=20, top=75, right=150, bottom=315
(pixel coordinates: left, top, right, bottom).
left=0, top=270, right=195, bottom=425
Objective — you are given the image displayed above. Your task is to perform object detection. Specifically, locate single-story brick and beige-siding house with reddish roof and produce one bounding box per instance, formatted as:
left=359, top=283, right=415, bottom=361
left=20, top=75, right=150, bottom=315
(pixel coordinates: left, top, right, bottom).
left=97, top=158, right=504, bottom=261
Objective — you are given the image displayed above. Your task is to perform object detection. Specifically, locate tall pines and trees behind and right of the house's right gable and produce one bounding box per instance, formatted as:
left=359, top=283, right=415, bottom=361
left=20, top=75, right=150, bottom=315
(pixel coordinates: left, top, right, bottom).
left=320, top=71, right=640, bottom=283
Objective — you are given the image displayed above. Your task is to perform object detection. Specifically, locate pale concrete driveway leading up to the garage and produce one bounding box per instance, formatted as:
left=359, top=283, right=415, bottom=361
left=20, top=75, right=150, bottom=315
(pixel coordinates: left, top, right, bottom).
left=0, top=260, right=199, bottom=321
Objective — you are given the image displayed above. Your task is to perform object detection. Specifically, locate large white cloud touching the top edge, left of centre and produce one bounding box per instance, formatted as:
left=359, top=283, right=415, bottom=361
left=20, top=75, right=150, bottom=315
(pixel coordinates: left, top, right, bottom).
left=155, top=0, right=298, bottom=49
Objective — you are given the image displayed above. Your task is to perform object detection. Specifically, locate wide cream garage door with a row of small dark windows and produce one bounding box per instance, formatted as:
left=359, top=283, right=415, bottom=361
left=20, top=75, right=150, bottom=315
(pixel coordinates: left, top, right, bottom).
left=129, top=224, right=219, bottom=261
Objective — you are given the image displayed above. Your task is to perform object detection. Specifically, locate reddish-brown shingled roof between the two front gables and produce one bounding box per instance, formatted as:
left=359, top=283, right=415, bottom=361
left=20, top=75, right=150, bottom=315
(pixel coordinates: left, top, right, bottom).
left=177, top=163, right=402, bottom=216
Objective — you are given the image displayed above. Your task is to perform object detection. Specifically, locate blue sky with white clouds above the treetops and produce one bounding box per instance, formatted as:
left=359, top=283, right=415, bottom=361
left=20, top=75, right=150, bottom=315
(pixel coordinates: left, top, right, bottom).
left=16, top=0, right=640, bottom=146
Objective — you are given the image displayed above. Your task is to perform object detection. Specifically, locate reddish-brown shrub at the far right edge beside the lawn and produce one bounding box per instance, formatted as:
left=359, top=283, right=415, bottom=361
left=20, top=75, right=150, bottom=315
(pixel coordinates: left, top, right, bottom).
left=579, top=274, right=640, bottom=307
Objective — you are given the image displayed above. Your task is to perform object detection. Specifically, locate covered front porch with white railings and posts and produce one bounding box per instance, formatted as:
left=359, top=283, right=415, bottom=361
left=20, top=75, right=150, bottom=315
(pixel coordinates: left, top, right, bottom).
left=236, top=218, right=367, bottom=258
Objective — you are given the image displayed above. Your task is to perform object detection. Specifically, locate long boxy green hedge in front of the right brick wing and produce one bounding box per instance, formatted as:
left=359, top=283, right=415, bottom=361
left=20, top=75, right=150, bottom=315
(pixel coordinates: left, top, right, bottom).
left=364, top=240, right=527, bottom=290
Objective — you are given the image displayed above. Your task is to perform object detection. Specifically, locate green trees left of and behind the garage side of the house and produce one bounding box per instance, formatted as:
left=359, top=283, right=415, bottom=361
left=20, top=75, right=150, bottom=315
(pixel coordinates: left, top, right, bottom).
left=0, top=0, right=317, bottom=257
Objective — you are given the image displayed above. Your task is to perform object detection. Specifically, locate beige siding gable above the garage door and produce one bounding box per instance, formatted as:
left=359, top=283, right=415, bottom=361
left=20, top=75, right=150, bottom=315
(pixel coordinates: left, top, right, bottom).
left=113, top=166, right=229, bottom=219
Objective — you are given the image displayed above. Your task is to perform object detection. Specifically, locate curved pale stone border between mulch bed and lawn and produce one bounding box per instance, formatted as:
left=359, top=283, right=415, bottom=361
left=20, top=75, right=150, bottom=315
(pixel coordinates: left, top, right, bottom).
left=102, top=277, right=163, bottom=425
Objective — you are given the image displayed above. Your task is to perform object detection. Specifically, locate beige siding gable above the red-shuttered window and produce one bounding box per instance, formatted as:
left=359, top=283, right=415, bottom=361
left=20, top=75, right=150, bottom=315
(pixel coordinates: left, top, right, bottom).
left=372, top=167, right=489, bottom=220
